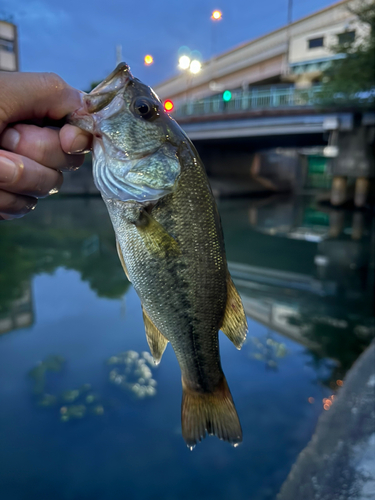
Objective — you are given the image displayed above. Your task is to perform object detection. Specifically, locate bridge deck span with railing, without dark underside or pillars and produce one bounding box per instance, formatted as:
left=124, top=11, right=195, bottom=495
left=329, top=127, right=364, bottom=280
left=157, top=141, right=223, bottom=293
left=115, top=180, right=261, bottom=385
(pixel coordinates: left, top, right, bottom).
left=173, top=85, right=353, bottom=141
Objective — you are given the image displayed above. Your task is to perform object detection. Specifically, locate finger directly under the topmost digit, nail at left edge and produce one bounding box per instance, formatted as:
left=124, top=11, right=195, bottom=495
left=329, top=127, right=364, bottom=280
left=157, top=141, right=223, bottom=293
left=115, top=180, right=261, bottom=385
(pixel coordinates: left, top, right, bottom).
left=0, top=124, right=84, bottom=170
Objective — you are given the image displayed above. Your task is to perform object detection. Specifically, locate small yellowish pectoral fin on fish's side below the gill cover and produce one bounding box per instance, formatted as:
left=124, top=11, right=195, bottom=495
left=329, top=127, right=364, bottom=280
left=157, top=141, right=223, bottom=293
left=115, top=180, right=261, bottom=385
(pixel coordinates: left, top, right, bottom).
left=136, top=212, right=181, bottom=258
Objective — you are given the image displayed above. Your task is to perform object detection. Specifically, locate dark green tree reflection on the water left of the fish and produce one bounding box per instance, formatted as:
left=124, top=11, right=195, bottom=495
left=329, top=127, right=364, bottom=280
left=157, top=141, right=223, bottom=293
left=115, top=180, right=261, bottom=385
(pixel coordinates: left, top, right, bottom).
left=0, top=199, right=129, bottom=333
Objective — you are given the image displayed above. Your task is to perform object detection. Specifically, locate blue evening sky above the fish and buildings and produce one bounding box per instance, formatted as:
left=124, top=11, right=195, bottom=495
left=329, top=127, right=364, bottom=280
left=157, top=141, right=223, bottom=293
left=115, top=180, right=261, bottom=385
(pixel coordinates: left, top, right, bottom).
left=0, top=0, right=333, bottom=90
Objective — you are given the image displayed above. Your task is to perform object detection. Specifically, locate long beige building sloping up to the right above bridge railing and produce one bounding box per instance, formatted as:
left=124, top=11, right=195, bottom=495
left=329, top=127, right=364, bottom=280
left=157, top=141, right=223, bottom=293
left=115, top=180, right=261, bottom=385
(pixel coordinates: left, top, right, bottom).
left=154, top=0, right=365, bottom=106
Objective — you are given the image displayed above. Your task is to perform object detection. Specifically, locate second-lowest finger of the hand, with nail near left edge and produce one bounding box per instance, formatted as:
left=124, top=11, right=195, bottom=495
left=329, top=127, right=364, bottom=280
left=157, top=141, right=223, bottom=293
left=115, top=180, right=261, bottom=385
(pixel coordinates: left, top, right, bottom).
left=0, top=151, right=63, bottom=198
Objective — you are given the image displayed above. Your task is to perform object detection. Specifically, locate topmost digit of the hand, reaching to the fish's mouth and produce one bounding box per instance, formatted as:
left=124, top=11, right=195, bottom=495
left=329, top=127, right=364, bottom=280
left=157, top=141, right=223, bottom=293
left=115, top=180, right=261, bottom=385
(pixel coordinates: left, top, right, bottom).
left=0, top=72, right=83, bottom=132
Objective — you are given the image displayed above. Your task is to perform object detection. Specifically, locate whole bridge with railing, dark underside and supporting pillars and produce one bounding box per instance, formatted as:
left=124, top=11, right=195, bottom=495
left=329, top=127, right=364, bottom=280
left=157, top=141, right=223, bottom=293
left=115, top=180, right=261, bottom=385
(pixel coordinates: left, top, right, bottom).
left=166, top=84, right=375, bottom=207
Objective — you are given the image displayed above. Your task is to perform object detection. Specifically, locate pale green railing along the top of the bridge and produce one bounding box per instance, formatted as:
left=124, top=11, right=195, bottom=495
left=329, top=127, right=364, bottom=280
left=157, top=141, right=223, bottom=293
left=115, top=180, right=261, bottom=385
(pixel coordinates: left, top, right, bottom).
left=174, top=85, right=323, bottom=117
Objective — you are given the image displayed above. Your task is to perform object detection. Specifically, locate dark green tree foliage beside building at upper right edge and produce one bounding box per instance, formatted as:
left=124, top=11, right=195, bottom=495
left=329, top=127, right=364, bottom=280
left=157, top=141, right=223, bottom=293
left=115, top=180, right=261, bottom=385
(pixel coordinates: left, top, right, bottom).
left=323, top=0, right=375, bottom=105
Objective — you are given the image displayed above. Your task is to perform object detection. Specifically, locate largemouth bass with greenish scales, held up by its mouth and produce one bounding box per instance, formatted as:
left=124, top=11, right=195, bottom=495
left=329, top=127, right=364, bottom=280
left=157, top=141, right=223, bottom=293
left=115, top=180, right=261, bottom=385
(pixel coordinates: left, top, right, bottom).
left=68, top=63, right=247, bottom=449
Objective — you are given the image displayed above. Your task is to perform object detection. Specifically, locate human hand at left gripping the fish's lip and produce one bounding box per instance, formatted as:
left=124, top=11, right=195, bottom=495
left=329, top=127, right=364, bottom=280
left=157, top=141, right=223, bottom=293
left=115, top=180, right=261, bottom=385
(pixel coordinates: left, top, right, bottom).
left=0, top=73, right=91, bottom=220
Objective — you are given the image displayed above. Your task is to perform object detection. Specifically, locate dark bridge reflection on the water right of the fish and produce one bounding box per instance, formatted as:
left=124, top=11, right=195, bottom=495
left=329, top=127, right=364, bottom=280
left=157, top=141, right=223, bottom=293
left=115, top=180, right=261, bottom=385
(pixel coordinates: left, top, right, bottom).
left=222, top=193, right=375, bottom=388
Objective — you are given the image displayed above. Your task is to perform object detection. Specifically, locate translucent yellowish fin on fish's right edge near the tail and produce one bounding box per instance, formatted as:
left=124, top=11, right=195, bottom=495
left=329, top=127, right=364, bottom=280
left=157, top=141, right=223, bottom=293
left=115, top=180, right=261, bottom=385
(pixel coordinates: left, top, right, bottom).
left=220, top=274, right=247, bottom=349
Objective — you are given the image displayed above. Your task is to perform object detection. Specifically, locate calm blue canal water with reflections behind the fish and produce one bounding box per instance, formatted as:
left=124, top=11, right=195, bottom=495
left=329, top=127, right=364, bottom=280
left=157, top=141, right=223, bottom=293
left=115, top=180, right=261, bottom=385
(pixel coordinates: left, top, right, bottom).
left=0, top=196, right=374, bottom=500
